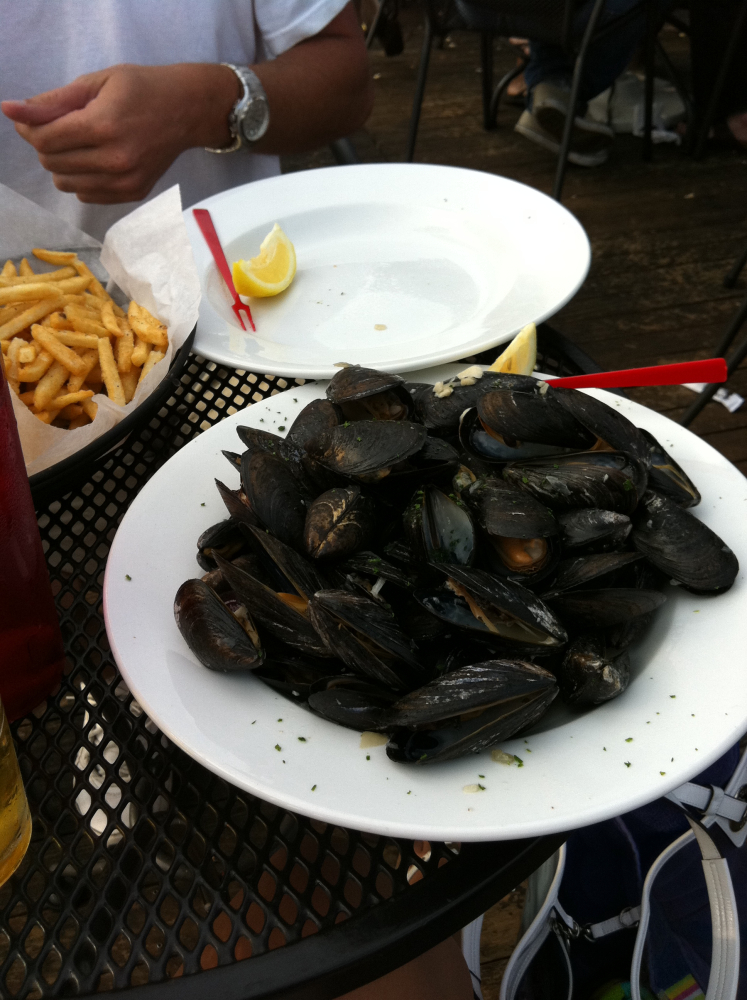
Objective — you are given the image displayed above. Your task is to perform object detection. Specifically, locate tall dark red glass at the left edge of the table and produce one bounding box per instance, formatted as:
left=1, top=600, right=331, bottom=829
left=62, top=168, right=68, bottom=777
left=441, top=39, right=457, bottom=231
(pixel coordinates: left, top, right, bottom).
left=0, top=363, right=65, bottom=721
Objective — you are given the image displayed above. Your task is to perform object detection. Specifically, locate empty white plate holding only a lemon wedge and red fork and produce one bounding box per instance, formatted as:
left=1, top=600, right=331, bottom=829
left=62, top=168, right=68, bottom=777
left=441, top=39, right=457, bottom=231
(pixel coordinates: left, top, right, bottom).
left=185, top=163, right=590, bottom=378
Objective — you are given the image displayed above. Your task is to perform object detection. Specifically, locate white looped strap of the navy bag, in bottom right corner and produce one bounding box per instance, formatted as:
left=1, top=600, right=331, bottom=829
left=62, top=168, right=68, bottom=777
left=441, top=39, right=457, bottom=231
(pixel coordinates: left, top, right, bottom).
left=630, top=820, right=740, bottom=1000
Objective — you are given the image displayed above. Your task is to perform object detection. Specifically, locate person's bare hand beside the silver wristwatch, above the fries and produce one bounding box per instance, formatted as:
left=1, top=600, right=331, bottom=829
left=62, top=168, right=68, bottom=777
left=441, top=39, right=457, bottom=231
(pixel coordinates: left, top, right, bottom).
left=0, top=63, right=239, bottom=205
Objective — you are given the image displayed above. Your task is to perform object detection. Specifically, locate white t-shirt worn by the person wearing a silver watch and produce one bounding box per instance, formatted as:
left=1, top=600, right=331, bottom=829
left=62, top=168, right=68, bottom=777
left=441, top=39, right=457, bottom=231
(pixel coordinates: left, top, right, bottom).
left=0, top=0, right=347, bottom=239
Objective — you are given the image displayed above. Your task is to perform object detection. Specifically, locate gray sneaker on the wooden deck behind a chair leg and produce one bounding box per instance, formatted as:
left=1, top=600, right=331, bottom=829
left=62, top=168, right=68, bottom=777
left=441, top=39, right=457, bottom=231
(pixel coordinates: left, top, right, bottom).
left=514, top=83, right=614, bottom=167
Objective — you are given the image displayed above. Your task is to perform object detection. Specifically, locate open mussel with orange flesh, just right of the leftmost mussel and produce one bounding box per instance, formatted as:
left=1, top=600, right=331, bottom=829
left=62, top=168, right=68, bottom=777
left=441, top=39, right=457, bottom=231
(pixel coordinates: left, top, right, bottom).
left=217, top=556, right=331, bottom=656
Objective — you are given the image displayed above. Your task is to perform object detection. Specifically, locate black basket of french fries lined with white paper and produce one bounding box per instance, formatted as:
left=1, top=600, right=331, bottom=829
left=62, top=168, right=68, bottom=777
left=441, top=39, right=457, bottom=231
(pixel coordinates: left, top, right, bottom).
left=0, top=185, right=199, bottom=504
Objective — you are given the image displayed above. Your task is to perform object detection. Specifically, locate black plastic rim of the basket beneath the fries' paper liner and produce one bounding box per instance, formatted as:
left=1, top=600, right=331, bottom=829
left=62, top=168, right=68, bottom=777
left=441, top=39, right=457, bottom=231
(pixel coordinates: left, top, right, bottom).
left=29, top=327, right=197, bottom=510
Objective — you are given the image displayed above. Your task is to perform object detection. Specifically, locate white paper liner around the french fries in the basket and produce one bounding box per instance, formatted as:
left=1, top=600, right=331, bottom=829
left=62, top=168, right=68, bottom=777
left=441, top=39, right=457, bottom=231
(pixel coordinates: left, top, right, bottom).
left=0, top=184, right=200, bottom=476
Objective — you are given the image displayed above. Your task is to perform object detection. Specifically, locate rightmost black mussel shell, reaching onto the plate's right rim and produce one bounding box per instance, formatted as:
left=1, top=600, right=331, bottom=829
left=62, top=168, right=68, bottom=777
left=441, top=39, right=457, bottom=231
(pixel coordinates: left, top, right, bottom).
left=631, top=491, right=739, bottom=593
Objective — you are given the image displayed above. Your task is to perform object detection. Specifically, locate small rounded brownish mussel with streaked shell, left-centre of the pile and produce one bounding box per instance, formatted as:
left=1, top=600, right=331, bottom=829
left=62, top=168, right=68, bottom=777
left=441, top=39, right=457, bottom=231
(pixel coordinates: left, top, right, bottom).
left=303, top=486, right=376, bottom=564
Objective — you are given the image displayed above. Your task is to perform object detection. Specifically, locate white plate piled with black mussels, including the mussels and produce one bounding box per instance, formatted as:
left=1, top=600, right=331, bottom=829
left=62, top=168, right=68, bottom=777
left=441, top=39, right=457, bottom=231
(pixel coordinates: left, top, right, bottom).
left=104, top=365, right=747, bottom=840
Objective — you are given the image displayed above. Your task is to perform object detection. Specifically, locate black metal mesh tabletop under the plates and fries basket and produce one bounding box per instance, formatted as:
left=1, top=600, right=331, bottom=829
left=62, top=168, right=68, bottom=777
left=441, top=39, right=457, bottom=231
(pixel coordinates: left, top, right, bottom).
left=0, top=331, right=586, bottom=1000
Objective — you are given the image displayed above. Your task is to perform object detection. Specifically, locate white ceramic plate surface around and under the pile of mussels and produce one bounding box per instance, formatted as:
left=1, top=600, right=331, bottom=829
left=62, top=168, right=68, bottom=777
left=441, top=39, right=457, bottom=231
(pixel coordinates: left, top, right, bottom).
left=104, top=374, right=747, bottom=841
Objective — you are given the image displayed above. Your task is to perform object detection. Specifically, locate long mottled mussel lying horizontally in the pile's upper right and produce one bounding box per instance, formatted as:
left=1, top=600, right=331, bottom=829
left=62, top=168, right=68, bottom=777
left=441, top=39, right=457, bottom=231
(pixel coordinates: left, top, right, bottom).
left=503, top=451, right=640, bottom=514
